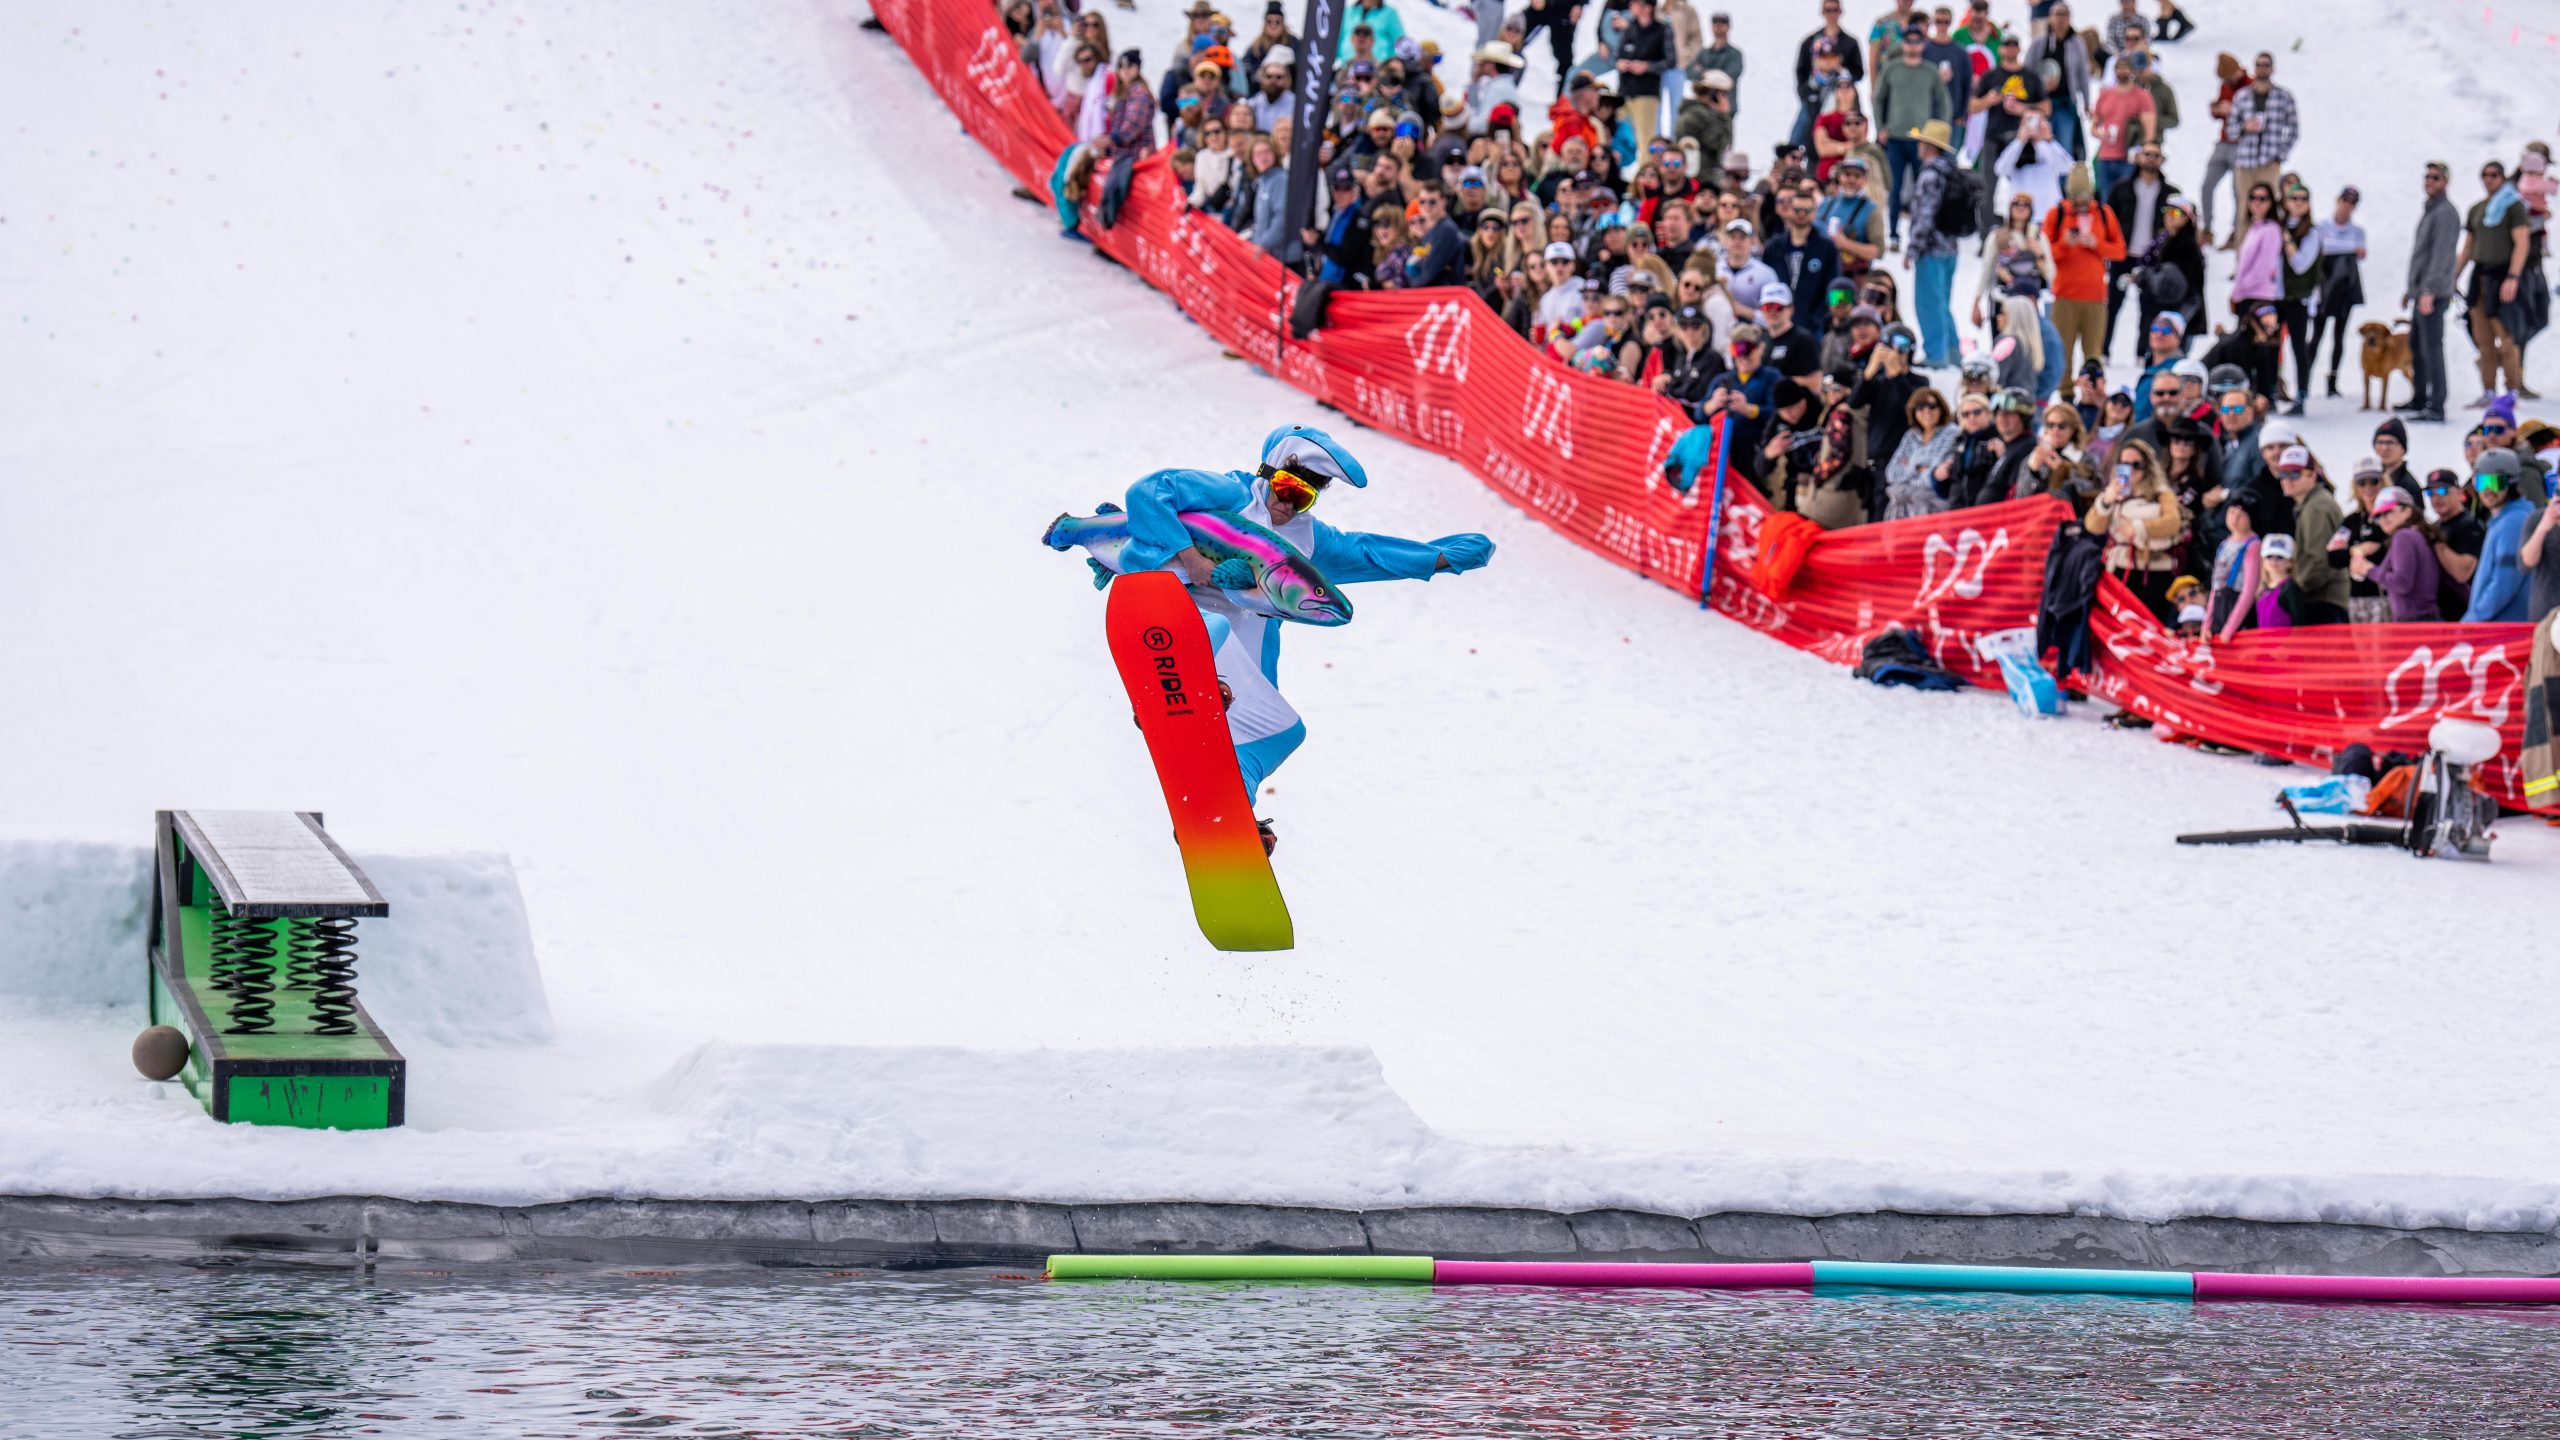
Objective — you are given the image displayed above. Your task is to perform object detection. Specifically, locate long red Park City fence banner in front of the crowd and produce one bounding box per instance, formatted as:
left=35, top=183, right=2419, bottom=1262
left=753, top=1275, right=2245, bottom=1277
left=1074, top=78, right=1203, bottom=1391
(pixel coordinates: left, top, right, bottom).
left=873, top=0, right=2532, bottom=805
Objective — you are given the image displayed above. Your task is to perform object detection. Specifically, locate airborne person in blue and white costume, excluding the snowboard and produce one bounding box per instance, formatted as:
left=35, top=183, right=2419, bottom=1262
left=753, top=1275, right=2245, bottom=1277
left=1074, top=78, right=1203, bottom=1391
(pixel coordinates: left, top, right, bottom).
left=1049, top=425, right=1492, bottom=848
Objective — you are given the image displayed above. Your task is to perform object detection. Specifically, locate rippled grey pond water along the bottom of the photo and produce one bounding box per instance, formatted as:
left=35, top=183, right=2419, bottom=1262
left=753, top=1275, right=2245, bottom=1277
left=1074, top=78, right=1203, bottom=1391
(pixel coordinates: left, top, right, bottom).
left=0, top=1266, right=2560, bottom=1440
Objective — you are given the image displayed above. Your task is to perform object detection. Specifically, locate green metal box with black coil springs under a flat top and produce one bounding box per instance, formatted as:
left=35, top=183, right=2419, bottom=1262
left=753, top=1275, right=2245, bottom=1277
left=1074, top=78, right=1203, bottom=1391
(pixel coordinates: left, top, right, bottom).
left=136, top=810, right=410, bottom=1130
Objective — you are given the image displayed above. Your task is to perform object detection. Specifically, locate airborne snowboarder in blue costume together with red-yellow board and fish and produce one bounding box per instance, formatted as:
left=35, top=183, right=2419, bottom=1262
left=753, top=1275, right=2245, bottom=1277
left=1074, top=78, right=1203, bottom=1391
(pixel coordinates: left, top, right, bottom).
left=1042, top=425, right=1492, bottom=951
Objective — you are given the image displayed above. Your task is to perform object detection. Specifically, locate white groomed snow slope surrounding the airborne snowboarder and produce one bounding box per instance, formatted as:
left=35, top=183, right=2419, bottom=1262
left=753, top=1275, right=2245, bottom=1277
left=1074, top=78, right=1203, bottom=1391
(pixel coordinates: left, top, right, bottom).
left=0, top=0, right=2560, bottom=1230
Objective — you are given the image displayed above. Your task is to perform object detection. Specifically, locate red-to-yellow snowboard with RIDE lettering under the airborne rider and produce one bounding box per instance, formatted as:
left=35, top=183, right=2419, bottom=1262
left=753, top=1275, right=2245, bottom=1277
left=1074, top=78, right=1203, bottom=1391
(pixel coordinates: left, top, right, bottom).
left=1103, top=571, right=1293, bottom=951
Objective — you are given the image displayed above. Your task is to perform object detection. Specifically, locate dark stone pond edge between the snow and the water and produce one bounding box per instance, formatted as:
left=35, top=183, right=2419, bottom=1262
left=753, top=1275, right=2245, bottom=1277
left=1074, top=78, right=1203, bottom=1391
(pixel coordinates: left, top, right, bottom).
left=0, top=1197, right=2560, bottom=1276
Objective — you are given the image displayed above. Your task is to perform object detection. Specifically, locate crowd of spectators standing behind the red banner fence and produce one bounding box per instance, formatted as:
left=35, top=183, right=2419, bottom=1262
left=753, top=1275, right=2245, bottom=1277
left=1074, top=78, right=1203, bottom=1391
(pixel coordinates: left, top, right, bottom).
left=1004, top=0, right=2560, bottom=635
